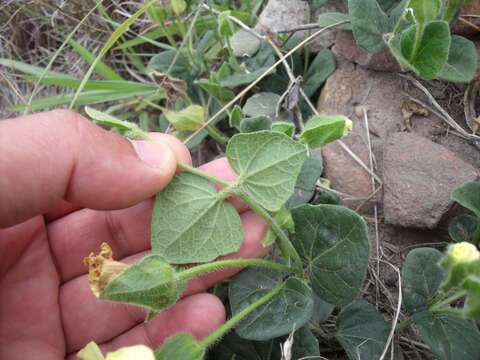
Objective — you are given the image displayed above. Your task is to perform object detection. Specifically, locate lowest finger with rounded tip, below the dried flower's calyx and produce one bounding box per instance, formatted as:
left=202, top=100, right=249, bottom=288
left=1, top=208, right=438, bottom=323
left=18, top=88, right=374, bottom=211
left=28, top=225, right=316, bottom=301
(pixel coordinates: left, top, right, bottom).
left=63, top=294, right=225, bottom=352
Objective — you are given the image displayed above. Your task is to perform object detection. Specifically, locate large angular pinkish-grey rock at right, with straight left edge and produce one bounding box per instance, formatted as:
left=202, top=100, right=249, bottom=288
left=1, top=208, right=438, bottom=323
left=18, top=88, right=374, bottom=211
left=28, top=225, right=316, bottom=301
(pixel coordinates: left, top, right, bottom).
left=383, top=133, right=478, bottom=229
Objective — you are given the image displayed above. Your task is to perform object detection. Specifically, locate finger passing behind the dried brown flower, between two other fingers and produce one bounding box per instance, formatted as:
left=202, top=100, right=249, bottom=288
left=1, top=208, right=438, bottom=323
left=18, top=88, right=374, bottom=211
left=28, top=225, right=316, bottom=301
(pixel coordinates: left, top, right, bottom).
left=60, top=211, right=268, bottom=347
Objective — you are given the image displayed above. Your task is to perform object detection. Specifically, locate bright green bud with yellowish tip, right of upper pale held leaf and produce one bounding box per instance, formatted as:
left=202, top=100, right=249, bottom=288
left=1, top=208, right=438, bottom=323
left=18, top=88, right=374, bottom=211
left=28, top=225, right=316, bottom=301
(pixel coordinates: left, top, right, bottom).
left=300, top=115, right=352, bottom=149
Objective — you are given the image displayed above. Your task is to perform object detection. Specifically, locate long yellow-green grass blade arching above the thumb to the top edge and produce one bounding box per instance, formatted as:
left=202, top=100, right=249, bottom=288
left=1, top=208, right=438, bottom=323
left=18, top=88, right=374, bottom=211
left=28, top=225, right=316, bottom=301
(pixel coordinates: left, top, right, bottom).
left=69, top=0, right=157, bottom=109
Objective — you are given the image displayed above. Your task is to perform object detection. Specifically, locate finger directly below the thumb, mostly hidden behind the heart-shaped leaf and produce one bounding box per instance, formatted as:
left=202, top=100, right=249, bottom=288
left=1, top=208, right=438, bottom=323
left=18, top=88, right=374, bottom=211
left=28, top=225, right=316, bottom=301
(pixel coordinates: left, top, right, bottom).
left=48, top=159, right=248, bottom=281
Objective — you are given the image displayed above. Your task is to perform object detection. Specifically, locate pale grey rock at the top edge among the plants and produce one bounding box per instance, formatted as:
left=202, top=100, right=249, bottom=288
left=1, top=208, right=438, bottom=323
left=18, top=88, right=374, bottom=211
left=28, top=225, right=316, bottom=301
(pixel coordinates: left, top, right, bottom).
left=255, top=0, right=310, bottom=38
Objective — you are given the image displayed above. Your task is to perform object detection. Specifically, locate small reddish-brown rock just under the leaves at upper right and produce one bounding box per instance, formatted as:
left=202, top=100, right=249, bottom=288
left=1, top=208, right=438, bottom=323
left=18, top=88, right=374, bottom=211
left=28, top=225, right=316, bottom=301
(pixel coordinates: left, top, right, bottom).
left=332, top=30, right=400, bottom=72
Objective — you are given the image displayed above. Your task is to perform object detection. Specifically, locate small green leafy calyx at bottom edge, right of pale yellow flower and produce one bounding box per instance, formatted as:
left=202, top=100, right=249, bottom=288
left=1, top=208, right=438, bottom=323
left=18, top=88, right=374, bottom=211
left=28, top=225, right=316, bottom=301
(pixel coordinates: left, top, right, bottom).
left=155, top=333, right=205, bottom=360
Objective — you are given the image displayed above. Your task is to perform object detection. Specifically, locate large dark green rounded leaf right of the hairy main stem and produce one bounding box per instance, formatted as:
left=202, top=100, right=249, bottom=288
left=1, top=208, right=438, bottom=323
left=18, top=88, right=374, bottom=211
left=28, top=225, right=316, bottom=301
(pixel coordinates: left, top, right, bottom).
left=292, top=204, right=369, bottom=305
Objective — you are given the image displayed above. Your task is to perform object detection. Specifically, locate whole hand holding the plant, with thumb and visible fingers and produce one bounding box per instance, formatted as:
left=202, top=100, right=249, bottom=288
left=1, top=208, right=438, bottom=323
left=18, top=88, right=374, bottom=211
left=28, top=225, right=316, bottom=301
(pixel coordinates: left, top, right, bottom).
left=0, top=110, right=268, bottom=360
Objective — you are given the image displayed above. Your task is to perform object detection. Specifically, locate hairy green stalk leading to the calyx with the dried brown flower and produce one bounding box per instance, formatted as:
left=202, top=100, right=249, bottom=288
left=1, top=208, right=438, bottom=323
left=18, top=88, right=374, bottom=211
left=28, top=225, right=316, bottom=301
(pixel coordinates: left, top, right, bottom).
left=178, top=259, right=292, bottom=280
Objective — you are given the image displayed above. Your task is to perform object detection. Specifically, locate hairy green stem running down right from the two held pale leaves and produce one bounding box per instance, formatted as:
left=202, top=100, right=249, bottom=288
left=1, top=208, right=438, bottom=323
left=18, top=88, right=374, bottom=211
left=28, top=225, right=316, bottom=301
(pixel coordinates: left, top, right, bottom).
left=237, top=193, right=303, bottom=274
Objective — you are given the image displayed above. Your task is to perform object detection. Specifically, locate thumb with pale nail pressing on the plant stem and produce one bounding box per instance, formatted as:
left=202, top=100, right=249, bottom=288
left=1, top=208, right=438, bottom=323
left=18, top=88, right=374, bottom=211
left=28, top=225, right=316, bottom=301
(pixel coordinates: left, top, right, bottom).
left=0, top=110, right=190, bottom=227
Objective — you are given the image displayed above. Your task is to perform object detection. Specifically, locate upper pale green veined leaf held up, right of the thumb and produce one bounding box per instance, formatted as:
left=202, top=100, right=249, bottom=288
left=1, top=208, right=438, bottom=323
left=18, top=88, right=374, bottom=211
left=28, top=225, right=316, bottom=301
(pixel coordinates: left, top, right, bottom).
left=226, top=131, right=307, bottom=211
